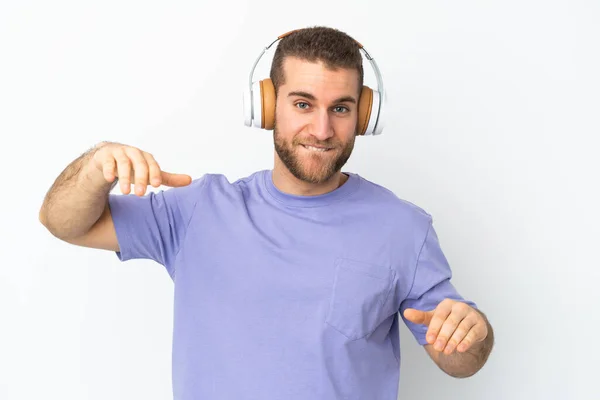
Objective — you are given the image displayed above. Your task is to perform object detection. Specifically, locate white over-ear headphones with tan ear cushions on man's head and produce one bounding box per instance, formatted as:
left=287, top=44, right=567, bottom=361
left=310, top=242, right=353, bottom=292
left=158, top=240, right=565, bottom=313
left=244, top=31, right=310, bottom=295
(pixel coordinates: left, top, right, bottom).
left=243, top=30, right=386, bottom=136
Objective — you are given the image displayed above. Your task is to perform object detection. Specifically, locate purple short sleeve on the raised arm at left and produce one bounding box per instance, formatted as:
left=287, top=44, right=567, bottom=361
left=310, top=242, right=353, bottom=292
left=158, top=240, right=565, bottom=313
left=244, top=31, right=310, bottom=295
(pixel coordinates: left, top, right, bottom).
left=108, top=176, right=207, bottom=278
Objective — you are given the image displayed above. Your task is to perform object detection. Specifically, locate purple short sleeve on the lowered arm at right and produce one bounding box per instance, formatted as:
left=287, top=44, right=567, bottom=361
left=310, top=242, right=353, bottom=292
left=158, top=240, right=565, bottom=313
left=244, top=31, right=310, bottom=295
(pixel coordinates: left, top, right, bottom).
left=400, top=222, right=477, bottom=345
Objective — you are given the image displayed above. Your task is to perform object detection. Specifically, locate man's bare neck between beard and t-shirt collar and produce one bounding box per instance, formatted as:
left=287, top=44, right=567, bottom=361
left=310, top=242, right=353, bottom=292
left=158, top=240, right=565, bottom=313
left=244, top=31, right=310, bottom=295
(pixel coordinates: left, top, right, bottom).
left=273, top=159, right=348, bottom=196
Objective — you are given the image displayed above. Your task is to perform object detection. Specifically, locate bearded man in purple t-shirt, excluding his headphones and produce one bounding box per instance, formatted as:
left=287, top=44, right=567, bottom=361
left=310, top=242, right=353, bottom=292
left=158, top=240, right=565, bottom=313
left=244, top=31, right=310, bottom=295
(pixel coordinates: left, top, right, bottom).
left=40, top=27, right=493, bottom=400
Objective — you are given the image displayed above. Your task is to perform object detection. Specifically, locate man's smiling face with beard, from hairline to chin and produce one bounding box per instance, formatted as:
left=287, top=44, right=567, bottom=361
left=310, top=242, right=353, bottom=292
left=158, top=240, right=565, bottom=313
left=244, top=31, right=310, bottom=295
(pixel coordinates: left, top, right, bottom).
left=274, top=57, right=359, bottom=184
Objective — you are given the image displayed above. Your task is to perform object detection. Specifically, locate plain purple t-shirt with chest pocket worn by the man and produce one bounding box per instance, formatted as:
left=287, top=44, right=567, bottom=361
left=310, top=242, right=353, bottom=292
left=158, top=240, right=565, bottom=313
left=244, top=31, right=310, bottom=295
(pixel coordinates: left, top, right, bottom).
left=109, top=170, right=476, bottom=400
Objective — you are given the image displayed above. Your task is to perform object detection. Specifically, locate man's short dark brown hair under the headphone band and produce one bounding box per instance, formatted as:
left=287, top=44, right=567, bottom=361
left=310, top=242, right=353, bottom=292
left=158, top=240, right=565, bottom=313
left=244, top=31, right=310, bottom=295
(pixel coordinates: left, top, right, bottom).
left=270, top=26, right=364, bottom=94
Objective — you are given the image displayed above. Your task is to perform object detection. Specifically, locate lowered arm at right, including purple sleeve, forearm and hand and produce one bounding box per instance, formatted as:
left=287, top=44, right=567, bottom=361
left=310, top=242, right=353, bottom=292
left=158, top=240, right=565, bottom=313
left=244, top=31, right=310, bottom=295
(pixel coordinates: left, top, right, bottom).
left=400, top=222, right=494, bottom=378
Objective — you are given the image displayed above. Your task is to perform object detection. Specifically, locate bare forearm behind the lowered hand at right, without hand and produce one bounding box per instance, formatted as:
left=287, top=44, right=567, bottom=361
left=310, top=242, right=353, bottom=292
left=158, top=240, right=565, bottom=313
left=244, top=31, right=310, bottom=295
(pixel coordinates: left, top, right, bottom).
left=435, top=311, right=494, bottom=378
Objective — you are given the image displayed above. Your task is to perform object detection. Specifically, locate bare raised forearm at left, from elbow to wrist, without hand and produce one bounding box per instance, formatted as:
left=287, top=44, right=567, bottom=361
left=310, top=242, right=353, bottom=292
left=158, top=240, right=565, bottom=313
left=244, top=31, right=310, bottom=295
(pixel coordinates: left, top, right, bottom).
left=39, top=143, right=116, bottom=239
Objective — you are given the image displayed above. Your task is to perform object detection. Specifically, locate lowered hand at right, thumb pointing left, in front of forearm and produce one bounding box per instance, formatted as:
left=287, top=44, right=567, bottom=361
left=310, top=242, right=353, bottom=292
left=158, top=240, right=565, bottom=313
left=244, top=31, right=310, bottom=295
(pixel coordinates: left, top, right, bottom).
left=404, top=299, right=488, bottom=355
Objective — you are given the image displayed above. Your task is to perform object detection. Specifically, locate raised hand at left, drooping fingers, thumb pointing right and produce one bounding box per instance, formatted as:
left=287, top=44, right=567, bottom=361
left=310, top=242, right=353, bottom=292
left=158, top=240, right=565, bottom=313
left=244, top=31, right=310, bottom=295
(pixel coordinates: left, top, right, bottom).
left=92, top=143, right=192, bottom=196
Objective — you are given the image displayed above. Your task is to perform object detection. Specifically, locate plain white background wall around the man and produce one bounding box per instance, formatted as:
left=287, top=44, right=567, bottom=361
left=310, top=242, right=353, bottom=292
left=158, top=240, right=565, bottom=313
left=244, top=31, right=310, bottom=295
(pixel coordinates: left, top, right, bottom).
left=0, top=0, right=600, bottom=400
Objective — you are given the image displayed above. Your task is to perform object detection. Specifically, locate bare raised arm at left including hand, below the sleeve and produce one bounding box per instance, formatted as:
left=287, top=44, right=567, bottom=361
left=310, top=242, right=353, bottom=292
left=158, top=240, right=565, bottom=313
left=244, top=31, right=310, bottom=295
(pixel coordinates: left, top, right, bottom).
left=39, top=142, right=191, bottom=247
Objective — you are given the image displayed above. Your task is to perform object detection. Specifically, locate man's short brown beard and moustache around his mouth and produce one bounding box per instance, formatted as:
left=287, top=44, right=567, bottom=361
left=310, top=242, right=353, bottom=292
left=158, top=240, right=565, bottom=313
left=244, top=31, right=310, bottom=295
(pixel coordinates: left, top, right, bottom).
left=273, top=124, right=356, bottom=184
